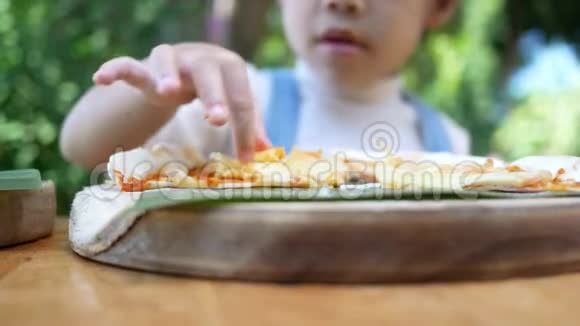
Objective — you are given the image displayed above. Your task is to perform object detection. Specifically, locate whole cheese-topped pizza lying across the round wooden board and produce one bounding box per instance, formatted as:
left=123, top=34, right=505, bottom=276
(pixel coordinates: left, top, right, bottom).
left=108, top=145, right=580, bottom=193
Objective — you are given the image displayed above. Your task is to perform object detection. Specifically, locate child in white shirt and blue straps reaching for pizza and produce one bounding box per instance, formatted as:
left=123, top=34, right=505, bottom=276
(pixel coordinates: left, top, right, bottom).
left=61, top=0, right=469, bottom=168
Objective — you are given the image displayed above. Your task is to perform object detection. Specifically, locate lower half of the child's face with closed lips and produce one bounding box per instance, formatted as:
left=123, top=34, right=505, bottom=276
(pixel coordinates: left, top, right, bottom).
left=280, top=0, right=456, bottom=86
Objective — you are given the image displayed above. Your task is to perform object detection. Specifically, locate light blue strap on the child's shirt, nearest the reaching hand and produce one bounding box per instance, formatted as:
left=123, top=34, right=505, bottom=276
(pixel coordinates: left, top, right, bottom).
left=265, top=69, right=302, bottom=153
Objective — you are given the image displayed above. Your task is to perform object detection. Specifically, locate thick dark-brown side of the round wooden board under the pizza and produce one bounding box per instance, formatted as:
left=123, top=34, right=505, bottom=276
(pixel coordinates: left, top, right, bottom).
left=91, top=198, right=580, bottom=283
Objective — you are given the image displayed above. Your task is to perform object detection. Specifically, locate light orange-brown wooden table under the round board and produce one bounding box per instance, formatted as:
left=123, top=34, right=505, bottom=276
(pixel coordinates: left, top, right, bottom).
left=0, top=219, right=580, bottom=326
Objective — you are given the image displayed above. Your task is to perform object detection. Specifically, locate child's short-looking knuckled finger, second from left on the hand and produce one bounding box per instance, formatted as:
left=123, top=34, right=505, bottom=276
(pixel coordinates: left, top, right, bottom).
left=149, top=44, right=181, bottom=95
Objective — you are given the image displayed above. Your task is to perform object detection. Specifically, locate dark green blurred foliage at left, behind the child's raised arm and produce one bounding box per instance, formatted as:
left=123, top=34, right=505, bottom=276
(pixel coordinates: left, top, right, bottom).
left=0, top=0, right=206, bottom=213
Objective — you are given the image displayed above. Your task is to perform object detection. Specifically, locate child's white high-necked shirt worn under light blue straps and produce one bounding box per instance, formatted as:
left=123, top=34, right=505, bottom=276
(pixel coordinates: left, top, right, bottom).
left=146, top=63, right=470, bottom=155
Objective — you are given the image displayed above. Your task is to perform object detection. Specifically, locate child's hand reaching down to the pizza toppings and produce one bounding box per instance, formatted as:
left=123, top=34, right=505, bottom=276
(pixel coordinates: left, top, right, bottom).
left=94, top=43, right=270, bottom=161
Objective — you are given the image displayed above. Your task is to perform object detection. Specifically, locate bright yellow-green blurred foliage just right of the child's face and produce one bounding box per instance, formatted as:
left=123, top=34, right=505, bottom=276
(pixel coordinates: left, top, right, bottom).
left=405, top=0, right=505, bottom=154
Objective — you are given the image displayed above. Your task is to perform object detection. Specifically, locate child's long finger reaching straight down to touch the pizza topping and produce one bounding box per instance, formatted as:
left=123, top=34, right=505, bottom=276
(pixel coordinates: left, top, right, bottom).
left=222, top=58, right=257, bottom=161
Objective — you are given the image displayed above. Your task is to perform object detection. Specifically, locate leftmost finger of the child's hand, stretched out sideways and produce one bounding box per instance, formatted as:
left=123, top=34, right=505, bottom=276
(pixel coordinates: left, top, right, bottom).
left=93, top=57, right=155, bottom=92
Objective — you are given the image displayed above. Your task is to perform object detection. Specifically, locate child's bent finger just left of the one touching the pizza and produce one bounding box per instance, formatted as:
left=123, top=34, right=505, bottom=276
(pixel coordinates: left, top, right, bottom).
left=192, top=63, right=228, bottom=126
